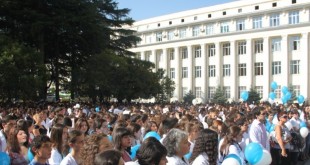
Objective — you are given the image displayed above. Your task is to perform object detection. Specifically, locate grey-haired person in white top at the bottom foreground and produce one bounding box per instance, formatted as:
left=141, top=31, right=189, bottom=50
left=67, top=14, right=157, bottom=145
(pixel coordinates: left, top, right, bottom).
left=162, top=128, right=190, bottom=165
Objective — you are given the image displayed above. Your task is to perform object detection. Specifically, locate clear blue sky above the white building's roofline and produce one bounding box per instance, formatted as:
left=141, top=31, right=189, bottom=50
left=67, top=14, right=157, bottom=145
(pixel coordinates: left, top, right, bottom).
left=115, top=0, right=236, bottom=21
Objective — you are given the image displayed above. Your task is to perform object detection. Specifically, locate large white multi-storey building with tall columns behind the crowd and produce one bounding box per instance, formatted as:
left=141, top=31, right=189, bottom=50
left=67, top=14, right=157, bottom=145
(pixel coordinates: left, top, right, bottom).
left=125, top=0, right=310, bottom=101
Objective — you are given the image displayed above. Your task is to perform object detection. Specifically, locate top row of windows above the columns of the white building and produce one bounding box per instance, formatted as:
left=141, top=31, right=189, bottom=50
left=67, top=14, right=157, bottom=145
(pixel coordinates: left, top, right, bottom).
left=150, top=11, right=300, bottom=43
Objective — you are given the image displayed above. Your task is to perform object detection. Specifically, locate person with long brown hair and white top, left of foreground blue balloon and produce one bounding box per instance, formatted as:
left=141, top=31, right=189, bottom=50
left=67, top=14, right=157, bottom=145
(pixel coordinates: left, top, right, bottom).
left=218, top=126, right=246, bottom=165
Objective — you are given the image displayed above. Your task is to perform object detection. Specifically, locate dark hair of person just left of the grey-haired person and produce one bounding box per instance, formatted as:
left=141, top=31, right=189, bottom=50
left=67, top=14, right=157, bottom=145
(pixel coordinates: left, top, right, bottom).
left=136, top=137, right=167, bottom=165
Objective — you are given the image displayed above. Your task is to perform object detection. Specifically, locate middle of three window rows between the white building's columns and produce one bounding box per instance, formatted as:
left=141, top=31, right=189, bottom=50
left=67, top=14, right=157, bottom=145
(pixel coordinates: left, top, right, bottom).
left=169, top=60, right=300, bottom=79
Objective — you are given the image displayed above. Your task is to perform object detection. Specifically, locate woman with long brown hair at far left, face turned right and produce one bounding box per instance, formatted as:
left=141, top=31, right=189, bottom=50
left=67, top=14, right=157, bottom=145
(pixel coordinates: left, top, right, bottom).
left=7, top=126, right=28, bottom=165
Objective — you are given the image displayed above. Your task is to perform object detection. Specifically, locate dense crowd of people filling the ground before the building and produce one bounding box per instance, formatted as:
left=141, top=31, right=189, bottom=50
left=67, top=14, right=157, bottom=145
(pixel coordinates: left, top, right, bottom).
left=0, top=103, right=310, bottom=165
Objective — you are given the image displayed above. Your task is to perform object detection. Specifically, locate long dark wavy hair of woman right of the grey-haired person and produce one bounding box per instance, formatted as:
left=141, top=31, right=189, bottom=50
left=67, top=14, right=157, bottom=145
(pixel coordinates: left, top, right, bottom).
left=190, top=129, right=218, bottom=165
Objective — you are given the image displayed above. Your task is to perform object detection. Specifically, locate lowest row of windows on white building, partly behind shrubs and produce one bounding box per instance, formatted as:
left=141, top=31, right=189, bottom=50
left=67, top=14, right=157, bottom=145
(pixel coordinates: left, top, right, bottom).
left=186, top=85, right=300, bottom=99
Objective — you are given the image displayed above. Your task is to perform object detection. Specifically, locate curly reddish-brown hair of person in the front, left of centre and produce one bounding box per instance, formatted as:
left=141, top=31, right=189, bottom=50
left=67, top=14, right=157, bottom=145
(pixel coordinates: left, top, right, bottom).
left=81, top=133, right=113, bottom=165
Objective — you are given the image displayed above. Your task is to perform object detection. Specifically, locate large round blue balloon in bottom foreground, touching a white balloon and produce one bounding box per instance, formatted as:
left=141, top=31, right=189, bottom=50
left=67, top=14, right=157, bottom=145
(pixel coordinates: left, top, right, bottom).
left=244, top=143, right=263, bottom=164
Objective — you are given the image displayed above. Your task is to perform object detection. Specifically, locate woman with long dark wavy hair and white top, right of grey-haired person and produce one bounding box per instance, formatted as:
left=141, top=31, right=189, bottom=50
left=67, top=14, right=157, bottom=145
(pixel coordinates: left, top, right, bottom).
left=190, top=129, right=218, bottom=165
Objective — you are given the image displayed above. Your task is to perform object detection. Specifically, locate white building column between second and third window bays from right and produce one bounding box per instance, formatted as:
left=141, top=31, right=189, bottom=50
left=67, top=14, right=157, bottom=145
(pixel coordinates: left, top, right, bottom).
left=262, top=37, right=270, bottom=98
